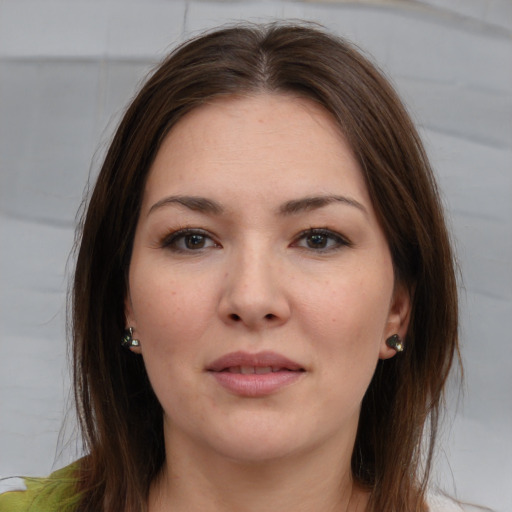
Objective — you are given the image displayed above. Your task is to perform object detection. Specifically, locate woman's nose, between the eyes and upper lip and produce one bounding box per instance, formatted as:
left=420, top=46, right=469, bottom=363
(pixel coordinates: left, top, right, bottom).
left=219, top=243, right=291, bottom=330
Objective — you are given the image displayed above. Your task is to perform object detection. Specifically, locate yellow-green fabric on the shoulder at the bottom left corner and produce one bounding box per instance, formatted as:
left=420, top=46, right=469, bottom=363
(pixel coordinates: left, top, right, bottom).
left=0, top=463, right=78, bottom=512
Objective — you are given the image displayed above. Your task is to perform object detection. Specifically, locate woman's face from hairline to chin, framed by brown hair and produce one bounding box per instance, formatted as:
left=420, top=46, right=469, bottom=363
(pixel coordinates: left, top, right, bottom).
left=126, top=94, right=409, bottom=461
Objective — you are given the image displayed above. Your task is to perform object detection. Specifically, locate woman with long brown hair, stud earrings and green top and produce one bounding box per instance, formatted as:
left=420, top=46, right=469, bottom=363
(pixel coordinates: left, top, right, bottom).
left=0, top=25, right=459, bottom=512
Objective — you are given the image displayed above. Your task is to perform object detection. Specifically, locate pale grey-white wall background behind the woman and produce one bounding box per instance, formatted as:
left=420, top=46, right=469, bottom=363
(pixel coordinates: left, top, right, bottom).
left=0, top=0, right=512, bottom=512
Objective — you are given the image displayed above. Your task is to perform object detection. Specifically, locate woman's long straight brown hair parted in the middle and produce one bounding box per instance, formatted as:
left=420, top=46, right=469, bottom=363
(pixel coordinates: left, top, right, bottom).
left=72, top=24, right=458, bottom=512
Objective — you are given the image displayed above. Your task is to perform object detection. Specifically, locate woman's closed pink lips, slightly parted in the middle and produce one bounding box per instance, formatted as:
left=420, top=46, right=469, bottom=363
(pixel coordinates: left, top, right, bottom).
left=206, top=351, right=305, bottom=397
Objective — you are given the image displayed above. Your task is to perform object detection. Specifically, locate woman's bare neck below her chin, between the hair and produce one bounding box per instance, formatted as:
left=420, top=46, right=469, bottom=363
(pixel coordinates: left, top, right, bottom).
left=149, top=430, right=368, bottom=512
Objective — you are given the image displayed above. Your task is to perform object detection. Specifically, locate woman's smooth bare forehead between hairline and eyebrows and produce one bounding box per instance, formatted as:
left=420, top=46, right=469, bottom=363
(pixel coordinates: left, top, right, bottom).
left=142, top=94, right=368, bottom=209
